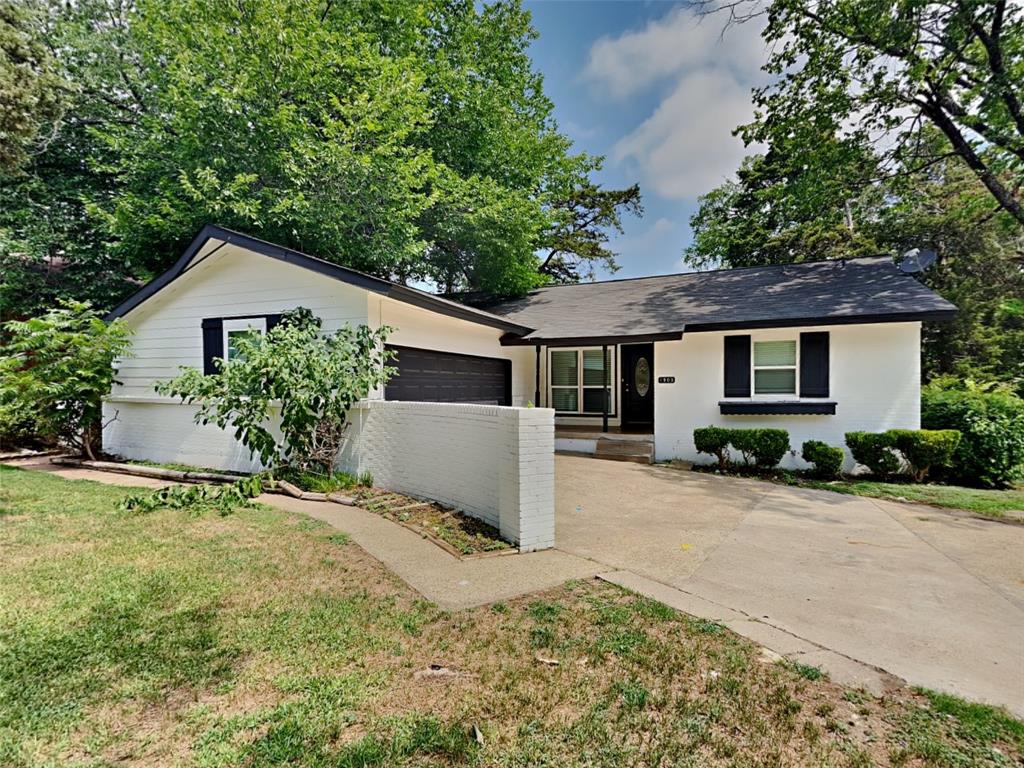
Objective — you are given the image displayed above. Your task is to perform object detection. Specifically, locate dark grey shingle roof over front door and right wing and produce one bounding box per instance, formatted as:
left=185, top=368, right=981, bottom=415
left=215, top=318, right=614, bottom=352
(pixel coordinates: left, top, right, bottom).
left=486, top=256, right=955, bottom=342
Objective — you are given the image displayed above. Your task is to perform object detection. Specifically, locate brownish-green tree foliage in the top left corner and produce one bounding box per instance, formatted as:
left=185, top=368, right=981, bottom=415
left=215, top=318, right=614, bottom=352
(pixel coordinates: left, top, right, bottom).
left=0, top=0, right=68, bottom=173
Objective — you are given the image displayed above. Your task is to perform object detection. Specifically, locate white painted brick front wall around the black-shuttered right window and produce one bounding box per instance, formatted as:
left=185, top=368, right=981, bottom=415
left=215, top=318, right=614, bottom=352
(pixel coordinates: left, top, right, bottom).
left=654, top=323, right=921, bottom=469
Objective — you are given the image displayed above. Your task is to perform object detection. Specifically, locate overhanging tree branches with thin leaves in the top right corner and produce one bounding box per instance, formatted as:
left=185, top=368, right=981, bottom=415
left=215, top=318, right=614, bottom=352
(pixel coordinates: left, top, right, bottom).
left=706, top=0, right=1024, bottom=224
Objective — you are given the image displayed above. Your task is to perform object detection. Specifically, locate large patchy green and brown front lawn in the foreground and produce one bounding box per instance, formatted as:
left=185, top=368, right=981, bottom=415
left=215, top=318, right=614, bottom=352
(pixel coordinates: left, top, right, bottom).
left=0, top=467, right=1024, bottom=768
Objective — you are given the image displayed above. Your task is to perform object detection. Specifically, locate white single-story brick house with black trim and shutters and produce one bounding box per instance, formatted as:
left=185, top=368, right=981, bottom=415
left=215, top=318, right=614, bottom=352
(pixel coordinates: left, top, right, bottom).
left=103, top=226, right=954, bottom=547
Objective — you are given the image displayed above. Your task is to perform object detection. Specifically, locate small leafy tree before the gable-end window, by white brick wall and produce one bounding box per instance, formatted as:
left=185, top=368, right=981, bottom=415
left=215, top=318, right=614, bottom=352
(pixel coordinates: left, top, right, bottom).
left=157, top=307, right=394, bottom=473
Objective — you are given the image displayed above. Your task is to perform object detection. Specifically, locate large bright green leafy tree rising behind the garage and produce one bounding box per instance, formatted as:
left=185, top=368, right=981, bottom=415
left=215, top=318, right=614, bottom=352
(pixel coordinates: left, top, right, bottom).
left=0, top=0, right=639, bottom=314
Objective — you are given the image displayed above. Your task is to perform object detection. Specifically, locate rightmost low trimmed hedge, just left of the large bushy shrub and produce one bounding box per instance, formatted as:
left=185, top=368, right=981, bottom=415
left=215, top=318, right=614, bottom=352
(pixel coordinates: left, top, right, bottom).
left=846, top=429, right=961, bottom=482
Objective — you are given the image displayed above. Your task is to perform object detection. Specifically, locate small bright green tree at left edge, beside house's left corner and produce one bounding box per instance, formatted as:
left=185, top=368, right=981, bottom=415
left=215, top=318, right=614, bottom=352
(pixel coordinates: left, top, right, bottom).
left=0, top=302, right=131, bottom=459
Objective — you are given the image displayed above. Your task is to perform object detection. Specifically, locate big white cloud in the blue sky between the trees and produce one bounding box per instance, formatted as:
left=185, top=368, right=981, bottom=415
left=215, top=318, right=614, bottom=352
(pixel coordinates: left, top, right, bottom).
left=583, top=7, right=767, bottom=200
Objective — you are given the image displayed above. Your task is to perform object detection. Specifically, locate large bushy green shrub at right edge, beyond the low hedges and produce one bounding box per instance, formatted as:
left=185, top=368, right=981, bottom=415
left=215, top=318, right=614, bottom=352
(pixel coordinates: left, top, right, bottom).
left=921, top=383, right=1024, bottom=487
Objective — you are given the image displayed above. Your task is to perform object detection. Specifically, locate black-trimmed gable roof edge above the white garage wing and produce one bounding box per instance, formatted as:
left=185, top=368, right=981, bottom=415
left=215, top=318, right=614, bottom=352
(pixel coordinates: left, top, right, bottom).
left=106, top=224, right=531, bottom=335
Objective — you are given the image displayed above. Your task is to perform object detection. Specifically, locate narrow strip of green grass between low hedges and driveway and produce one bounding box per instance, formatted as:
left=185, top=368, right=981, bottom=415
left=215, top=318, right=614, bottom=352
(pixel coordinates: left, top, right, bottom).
left=787, top=475, right=1024, bottom=517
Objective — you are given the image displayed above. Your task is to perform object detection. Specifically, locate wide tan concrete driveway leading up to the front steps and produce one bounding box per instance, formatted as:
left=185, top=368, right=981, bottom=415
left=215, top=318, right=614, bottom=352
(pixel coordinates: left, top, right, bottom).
left=556, top=456, right=1024, bottom=715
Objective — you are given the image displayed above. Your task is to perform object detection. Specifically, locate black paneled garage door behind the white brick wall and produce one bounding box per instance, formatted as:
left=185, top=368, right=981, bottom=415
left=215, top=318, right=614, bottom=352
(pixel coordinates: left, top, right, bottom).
left=384, top=345, right=512, bottom=406
